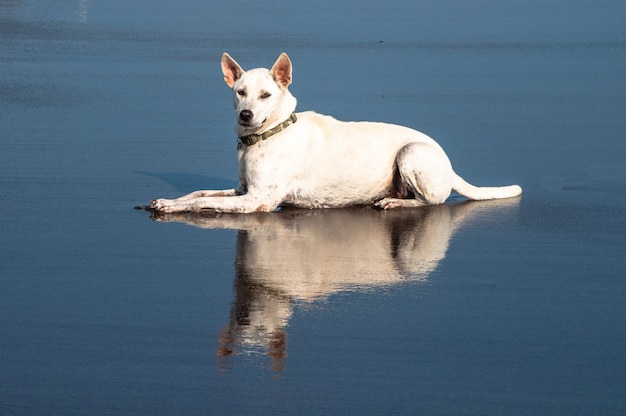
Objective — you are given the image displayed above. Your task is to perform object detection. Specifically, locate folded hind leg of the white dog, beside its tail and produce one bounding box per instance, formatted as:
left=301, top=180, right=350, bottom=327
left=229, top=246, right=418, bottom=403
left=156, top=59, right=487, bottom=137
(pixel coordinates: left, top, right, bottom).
left=375, top=143, right=453, bottom=209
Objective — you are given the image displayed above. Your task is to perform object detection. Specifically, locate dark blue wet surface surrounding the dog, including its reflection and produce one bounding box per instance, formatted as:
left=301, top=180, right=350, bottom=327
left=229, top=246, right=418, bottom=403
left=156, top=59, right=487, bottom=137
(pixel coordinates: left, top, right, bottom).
left=0, top=0, right=626, bottom=415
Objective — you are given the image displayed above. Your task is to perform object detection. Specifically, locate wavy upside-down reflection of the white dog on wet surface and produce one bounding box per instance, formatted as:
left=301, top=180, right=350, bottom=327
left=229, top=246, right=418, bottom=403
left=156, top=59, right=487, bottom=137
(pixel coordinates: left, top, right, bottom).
left=153, top=199, right=519, bottom=371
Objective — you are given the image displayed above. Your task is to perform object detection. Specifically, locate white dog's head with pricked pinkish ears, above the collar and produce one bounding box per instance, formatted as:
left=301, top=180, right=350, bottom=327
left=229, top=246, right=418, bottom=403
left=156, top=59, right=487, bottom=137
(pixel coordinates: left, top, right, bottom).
left=222, top=53, right=296, bottom=136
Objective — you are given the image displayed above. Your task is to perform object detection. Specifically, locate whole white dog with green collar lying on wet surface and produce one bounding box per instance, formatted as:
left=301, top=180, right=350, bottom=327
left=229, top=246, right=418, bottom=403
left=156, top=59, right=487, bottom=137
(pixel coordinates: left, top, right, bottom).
left=149, top=53, right=522, bottom=213
